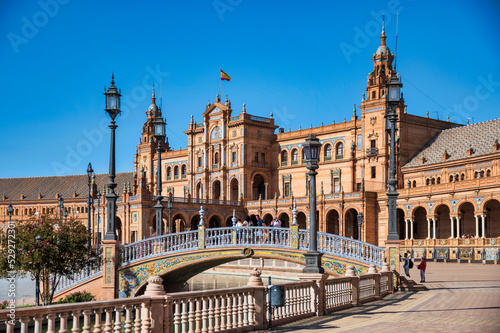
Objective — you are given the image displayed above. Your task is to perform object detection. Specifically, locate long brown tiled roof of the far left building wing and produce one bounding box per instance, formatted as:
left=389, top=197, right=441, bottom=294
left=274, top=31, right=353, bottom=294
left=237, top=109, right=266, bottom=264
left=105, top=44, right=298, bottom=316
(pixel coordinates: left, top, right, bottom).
left=0, top=172, right=134, bottom=201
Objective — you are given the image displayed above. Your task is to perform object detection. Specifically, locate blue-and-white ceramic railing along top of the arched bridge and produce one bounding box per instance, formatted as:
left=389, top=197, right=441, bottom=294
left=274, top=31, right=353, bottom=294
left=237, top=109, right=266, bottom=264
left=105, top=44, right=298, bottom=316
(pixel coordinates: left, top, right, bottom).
left=118, top=226, right=385, bottom=267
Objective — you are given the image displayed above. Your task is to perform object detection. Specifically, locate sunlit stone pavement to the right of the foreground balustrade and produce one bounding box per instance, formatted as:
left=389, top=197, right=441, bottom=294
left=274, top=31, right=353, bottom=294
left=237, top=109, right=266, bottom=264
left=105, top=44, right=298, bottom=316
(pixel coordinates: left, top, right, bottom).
left=258, top=262, right=500, bottom=333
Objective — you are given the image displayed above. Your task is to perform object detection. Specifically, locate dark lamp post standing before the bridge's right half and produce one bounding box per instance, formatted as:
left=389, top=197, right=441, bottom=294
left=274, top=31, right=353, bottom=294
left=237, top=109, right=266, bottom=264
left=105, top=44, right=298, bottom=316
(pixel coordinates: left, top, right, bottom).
left=303, top=134, right=325, bottom=273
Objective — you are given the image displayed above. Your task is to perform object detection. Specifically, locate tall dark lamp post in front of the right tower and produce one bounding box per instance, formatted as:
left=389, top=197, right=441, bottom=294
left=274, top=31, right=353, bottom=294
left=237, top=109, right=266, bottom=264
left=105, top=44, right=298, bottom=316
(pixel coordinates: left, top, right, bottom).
left=386, top=72, right=402, bottom=240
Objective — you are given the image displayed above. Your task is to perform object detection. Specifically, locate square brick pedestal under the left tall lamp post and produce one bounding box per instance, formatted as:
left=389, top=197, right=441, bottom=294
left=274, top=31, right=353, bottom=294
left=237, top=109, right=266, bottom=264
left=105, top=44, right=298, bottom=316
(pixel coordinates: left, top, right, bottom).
left=100, top=239, right=118, bottom=300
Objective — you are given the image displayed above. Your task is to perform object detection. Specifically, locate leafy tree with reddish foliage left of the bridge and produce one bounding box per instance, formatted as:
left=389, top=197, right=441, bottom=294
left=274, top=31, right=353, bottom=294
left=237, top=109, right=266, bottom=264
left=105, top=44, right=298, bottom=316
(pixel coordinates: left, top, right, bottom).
left=0, top=215, right=96, bottom=305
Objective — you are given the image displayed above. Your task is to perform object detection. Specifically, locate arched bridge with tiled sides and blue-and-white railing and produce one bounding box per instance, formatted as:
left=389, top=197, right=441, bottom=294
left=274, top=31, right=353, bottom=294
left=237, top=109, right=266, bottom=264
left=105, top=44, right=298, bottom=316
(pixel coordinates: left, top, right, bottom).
left=56, top=225, right=385, bottom=299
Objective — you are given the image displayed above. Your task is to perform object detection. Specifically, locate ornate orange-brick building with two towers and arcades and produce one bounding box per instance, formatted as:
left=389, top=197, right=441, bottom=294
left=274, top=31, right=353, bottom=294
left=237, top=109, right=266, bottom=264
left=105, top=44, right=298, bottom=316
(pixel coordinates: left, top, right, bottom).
left=0, top=26, right=500, bottom=256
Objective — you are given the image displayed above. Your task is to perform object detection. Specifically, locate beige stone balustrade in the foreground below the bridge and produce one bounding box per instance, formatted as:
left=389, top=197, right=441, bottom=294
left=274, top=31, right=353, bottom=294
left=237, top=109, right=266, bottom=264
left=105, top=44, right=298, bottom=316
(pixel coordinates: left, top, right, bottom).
left=0, top=264, right=393, bottom=333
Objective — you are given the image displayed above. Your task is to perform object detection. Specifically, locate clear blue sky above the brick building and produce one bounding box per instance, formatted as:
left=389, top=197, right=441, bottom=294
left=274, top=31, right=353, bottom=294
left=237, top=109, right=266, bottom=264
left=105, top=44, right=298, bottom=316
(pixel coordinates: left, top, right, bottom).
left=0, top=0, right=500, bottom=177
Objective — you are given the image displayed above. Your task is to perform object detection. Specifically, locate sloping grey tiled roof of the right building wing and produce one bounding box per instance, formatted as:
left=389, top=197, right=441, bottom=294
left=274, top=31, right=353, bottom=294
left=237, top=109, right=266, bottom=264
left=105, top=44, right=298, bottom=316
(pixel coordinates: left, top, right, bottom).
left=403, top=118, right=500, bottom=169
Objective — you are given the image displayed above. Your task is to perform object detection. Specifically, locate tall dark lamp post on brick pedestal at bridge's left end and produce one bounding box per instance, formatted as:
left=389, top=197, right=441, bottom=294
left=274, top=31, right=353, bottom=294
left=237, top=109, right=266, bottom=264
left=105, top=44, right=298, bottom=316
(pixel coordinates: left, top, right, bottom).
left=104, top=75, right=121, bottom=240
